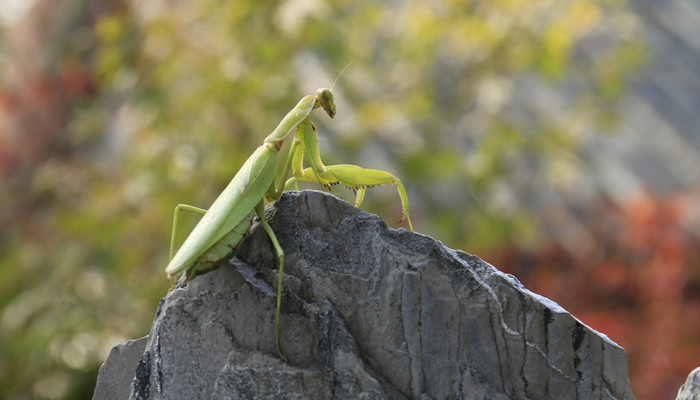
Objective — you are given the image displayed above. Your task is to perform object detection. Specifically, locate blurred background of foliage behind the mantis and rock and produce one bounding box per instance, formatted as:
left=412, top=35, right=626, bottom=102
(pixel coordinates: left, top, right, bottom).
left=0, top=0, right=700, bottom=400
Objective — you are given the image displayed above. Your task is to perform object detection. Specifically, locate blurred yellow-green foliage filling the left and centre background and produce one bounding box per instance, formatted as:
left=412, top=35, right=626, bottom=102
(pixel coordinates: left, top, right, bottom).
left=0, top=0, right=641, bottom=399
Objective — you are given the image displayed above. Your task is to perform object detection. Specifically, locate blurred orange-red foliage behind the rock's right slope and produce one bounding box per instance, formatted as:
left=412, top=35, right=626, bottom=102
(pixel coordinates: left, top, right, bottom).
left=485, top=192, right=700, bottom=400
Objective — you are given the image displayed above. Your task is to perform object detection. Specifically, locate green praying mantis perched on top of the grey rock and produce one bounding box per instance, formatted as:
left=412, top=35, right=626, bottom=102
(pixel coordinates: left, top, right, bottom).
left=165, top=72, right=413, bottom=360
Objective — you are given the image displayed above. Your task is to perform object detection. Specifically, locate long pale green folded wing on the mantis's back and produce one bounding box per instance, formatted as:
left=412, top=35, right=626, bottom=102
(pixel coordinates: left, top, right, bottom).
left=165, top=143, right=277, bottom=276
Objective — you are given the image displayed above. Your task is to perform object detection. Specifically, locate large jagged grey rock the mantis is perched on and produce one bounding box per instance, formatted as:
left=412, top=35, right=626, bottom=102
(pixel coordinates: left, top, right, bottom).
left=95, top=191, right=634, bottom=399
